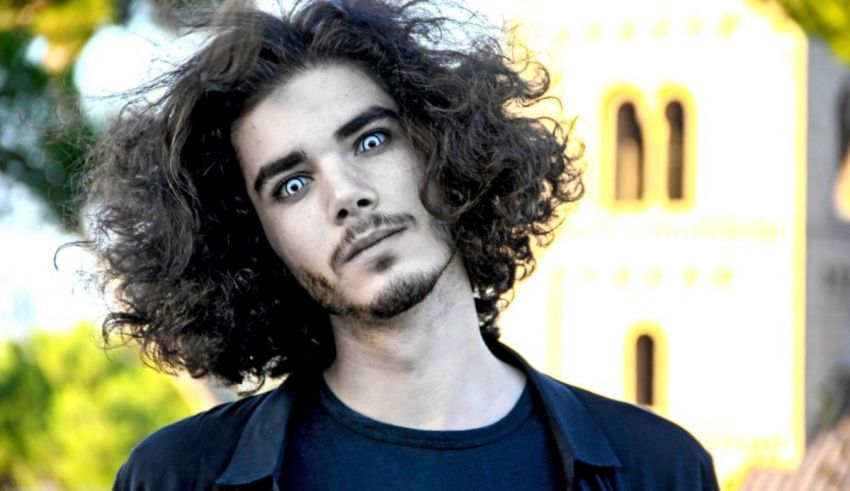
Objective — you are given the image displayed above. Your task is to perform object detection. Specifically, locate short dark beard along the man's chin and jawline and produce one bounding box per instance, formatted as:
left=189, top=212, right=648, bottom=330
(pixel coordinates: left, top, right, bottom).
left=293, top=254, right=454, bottom=322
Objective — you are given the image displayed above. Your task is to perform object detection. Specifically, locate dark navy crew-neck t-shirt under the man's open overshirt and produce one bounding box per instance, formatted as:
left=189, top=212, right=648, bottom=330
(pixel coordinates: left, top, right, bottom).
left=281, top=380, right=565, bottom=491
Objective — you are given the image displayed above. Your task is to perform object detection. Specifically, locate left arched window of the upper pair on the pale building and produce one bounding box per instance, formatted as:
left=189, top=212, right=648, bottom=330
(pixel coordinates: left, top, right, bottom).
left=614, top=103, right=645, bottom=201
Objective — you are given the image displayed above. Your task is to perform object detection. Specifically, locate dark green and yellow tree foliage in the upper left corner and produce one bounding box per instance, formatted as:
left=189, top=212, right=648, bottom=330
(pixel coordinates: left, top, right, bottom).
left=0, top=0, right=113, bottom=223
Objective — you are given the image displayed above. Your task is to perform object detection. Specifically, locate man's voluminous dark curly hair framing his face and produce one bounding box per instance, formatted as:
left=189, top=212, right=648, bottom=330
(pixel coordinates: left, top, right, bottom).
left=78, top=0, right=583, bottom=392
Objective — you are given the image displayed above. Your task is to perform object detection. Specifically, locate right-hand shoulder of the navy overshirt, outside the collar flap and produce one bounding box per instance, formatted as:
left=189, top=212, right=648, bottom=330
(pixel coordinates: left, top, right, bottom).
left=558, top=382, right=717, bottom=489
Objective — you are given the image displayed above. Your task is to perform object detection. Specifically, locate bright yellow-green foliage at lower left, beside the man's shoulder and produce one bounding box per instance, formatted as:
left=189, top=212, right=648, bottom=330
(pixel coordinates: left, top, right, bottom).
left=0, top=325, right=190, bottom=491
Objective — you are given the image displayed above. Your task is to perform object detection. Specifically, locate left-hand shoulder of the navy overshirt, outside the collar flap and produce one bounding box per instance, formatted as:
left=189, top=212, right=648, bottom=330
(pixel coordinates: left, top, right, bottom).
left=114, top=393, right=269, bottom=490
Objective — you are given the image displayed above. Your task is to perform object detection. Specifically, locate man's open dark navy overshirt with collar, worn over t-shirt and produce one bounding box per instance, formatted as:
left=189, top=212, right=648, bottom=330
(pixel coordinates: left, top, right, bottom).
left=114, top=344, right=718, bottom=491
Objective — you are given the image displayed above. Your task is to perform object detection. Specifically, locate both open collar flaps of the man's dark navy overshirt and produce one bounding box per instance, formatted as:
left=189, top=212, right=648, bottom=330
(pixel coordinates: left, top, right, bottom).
left=216, top=342, right=622, bottom=486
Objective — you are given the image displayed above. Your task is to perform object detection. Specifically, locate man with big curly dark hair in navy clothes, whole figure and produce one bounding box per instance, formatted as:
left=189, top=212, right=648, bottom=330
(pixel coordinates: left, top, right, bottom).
left=81, top=0, right=717, bottom=490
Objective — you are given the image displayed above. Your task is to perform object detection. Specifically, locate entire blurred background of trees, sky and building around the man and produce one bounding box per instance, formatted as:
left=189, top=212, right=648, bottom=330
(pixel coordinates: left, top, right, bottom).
left=0, top=0, right=850, bottom=490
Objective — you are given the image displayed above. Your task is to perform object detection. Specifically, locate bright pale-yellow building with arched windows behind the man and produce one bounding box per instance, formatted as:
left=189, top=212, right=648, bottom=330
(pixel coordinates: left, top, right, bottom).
left=502, top=0, right=850, bottom=489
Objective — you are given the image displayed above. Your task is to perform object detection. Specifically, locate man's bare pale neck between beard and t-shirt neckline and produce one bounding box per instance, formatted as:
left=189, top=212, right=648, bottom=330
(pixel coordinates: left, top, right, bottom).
left=325, top=257, right=525, bottom=430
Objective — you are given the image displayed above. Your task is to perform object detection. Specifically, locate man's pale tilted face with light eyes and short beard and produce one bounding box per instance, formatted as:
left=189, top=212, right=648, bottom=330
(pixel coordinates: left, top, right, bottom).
left=232, top=64, right=452, bottom=319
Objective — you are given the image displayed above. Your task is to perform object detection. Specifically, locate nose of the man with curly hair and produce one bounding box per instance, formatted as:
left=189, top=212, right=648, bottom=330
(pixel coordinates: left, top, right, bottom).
left=325, top=162, right=378, bottom=225
